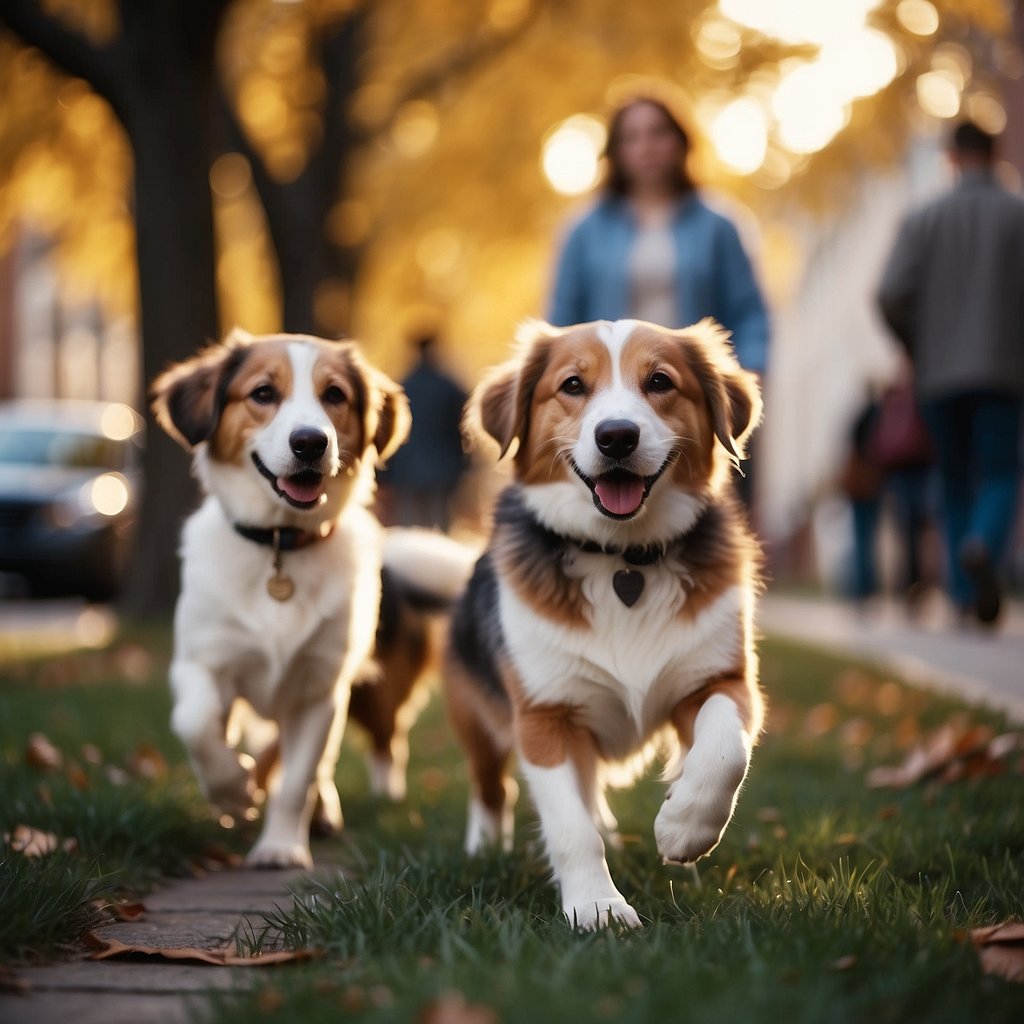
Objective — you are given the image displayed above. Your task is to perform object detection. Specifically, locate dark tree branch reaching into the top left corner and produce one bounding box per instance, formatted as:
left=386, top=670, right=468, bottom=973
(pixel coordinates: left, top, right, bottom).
left=0, top=0, right=131, bottom=123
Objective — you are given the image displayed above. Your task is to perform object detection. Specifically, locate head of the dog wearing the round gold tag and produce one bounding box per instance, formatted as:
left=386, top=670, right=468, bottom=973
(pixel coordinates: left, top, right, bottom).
left=152, top=331, right=410, bottom=525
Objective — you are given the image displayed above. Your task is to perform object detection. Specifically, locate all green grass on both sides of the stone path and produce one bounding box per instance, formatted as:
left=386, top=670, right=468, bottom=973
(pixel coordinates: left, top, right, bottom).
left=0, top=641, right=1024, bottom=1024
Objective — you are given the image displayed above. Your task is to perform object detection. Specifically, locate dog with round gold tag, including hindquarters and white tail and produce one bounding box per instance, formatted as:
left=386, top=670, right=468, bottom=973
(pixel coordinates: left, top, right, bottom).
left=153, top=331, right=469, bottom=867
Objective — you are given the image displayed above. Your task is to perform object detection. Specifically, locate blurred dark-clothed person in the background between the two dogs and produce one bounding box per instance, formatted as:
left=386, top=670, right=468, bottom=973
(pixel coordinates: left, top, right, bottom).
left=379, top=332, right=468, bottom=532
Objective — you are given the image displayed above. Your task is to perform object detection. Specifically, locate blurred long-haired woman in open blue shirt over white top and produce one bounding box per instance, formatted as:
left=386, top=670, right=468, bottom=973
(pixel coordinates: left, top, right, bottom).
left=548, top=94, right=768, bottom=504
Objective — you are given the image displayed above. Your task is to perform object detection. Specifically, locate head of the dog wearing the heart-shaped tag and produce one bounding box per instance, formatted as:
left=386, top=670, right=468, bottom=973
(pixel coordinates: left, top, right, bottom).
left=471, top=321, right=761, bottom=536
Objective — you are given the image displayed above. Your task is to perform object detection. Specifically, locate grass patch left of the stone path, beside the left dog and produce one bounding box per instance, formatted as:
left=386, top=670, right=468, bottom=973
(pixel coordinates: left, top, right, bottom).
left=0, top=631, right=240, bottom=961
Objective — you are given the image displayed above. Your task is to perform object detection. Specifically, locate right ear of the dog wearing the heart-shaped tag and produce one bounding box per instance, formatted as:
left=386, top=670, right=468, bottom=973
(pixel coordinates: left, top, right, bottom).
left=685, top=319, right=762, bottom=466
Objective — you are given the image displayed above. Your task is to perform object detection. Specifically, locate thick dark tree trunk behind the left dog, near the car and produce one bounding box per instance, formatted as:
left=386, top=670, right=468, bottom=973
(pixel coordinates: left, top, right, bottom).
left=120, top=0, right=223, bottom=618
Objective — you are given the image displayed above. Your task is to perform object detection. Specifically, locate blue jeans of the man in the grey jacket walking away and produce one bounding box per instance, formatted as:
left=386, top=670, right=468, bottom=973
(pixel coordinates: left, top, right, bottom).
left=922, top=391, right=1024, bottom=607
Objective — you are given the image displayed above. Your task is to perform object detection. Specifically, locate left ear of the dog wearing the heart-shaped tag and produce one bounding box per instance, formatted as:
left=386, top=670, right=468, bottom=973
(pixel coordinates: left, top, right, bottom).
left=465, top=321, right=555, bottom=459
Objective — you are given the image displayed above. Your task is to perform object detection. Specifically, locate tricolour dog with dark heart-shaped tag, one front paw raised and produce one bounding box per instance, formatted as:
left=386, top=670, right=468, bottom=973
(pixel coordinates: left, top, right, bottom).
left=445, top=321, right=763, bottom=928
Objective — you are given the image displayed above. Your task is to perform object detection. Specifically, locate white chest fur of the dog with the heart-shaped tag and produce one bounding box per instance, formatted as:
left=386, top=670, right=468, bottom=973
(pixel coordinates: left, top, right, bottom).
left=501, top=549, right=749, bottom=758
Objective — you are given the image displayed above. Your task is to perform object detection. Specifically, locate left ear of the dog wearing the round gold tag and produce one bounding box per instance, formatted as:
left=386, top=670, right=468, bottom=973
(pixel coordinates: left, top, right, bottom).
left=150, top=328, right=252, bottom=452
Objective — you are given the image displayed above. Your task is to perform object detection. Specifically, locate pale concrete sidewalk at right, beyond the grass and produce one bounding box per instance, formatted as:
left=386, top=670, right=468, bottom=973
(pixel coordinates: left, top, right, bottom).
left=758, top=592, right=1024, bottom=722
